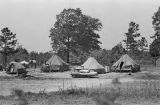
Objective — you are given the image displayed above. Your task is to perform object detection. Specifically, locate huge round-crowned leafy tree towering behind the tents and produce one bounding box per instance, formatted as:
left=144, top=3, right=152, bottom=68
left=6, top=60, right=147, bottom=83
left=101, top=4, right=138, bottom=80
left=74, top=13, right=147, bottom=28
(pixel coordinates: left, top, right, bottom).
left=49, top=8, right=102, bottom=63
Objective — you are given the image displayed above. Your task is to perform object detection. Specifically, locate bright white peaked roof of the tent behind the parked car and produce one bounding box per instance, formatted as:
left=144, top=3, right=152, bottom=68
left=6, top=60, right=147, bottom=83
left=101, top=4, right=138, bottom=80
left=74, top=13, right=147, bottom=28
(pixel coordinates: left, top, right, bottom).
left=82, top=57, right=104, bottom=69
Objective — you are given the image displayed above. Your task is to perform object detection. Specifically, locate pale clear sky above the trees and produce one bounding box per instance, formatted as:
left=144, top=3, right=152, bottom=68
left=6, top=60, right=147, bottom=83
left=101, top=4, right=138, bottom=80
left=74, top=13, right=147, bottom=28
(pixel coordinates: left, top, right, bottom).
left=0, top=0, right=160, bottom=52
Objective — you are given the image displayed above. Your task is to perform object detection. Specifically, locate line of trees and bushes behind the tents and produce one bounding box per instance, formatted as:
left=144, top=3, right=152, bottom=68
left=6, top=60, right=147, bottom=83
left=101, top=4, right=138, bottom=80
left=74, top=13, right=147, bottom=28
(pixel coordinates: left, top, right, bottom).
left=0, top=7, right=160, bottom=66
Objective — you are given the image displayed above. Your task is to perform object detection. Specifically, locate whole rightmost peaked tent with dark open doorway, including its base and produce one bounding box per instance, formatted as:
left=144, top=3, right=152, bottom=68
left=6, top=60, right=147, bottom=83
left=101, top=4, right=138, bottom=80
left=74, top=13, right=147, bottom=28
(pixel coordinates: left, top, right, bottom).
left=112, top=54, right=140, bottom=71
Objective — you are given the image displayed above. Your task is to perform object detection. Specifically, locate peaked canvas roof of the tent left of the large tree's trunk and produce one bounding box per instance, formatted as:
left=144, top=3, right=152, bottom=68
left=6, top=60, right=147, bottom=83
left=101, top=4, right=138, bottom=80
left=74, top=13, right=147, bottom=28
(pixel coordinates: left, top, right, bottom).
left=46, top=55, right=68, bottom=66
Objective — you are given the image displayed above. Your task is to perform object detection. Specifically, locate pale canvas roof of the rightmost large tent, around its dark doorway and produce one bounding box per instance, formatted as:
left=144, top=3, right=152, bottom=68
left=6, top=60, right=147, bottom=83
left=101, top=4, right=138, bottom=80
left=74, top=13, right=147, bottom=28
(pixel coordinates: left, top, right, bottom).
left=112, top=54, right=137, bottom=68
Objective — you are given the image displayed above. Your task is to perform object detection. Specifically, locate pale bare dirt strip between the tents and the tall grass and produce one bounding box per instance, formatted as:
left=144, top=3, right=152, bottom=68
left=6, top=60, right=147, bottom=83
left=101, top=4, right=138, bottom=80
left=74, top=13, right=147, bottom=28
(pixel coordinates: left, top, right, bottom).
left=0, top=69, right=134, bottom=96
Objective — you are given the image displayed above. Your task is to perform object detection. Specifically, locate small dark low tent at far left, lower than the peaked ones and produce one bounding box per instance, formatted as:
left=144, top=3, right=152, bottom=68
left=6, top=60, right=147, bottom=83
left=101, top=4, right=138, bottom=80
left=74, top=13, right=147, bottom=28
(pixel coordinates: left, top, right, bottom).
left=7, top=61, right=25, bottom=73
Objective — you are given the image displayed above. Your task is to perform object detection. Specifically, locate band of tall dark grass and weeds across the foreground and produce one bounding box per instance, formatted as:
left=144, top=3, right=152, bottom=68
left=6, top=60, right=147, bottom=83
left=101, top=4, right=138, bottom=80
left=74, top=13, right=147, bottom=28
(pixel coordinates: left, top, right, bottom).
left=1, top=78, right=160, bottom=105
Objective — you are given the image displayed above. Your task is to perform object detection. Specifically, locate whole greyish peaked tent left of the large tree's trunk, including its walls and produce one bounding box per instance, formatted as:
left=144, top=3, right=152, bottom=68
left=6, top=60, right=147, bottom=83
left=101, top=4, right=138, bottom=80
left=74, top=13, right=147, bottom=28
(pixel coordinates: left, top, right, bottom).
left=46, top=55, right=69, bottom=71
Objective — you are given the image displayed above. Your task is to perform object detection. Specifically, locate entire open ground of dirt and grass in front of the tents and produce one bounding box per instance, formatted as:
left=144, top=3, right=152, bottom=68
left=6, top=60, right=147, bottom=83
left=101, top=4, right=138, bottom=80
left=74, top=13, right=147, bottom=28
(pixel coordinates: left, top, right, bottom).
left=0, top=67, right=160, bottom=105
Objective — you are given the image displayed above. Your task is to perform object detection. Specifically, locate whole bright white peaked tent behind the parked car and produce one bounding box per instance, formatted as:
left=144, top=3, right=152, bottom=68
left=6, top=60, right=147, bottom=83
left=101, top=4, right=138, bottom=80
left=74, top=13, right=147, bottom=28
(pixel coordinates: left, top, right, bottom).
left=82, top=57, right=105, bottom=73
